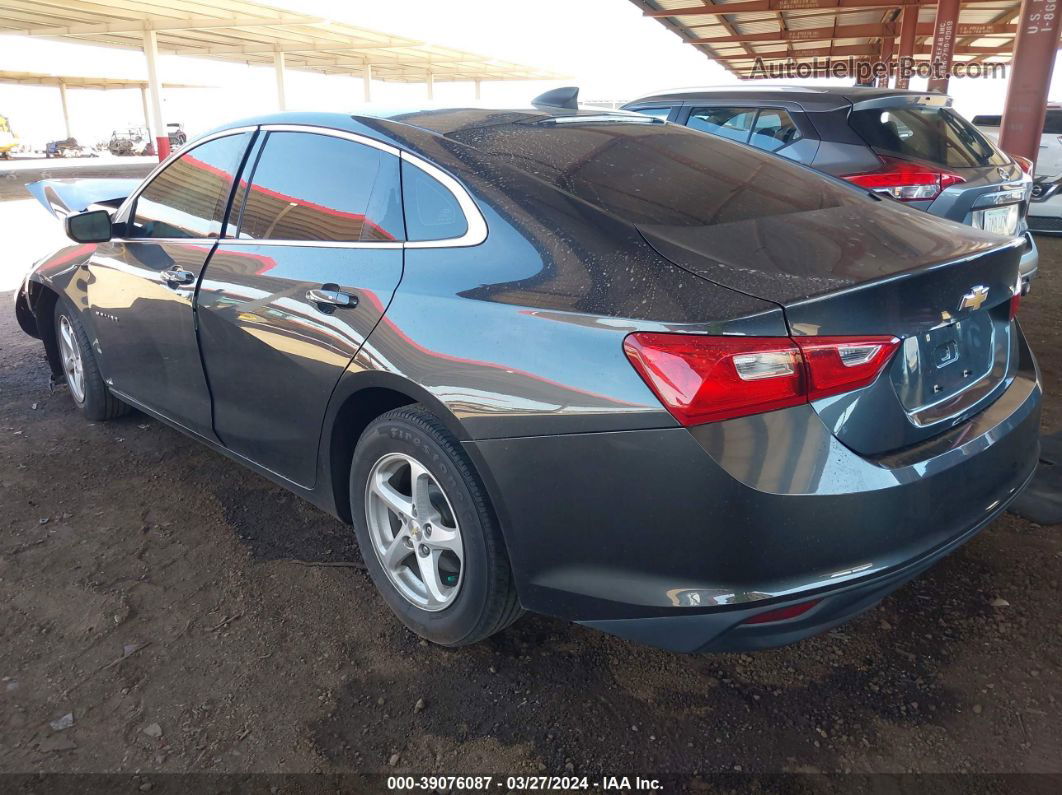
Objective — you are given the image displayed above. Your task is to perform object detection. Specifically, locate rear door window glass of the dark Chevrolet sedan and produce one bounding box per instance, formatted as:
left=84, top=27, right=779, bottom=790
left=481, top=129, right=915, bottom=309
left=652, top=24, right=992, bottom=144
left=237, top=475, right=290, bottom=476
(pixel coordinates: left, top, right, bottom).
left=234, top=132, right=404, bottom=243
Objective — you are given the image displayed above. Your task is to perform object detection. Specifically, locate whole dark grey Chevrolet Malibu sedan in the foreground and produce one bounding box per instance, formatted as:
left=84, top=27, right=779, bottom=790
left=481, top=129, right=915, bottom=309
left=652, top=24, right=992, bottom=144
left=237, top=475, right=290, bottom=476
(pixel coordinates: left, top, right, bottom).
left=16, top=108, right=1041, bottom=652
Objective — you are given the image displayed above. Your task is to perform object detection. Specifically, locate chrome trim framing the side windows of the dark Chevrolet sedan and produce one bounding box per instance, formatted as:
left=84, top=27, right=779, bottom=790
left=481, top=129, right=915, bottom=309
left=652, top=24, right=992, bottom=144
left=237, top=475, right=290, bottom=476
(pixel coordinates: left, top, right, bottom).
left=112, top=123, right=486, bottom=248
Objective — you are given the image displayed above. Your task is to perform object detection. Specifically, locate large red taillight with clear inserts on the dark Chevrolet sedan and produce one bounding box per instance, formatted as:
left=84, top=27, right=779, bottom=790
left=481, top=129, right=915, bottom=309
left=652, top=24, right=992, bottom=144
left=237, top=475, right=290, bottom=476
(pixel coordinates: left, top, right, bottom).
left=623, top=332, right=900, bottom=427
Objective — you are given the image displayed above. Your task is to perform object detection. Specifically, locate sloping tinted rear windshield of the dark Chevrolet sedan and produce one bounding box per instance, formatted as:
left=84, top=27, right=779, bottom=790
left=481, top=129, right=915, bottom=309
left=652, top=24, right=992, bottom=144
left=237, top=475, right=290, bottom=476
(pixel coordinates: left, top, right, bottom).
left=449, top=121, right=857, bottom=226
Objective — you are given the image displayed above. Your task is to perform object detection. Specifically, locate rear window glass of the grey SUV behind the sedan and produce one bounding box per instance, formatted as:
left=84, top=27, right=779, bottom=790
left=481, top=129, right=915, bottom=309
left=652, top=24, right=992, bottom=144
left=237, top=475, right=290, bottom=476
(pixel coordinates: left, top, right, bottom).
left=849, top=105, right=1010, bottom=169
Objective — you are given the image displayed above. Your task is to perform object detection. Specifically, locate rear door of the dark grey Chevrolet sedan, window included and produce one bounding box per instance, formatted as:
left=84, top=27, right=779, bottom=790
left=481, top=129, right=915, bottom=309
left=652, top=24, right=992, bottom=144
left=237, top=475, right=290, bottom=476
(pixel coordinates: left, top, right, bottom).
left=198, top=126, right=405, bottom=487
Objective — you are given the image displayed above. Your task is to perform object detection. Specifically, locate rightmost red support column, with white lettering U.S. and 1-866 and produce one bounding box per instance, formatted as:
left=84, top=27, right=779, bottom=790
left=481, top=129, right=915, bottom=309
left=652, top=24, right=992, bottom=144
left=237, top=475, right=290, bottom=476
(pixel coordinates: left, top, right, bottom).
left=999, top=0, right=1062, bottom=162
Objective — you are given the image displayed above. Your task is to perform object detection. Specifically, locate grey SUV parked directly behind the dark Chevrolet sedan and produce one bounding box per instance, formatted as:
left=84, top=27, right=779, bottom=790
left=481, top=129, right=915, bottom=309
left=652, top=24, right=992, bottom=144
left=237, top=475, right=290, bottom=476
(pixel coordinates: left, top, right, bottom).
left=623, top=86, right=1039, bottom=284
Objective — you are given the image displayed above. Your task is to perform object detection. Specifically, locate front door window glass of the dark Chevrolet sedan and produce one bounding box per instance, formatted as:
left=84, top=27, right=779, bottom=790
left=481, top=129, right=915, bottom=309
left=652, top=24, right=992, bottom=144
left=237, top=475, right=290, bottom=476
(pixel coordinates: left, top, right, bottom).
left=126, top=133, right=251, bottom=238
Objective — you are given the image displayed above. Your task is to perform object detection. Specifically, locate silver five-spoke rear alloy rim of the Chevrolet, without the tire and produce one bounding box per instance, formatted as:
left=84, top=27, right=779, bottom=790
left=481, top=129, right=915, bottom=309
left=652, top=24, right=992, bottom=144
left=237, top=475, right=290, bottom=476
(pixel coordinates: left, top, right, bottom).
left=365, top=453, right=464, bottom=612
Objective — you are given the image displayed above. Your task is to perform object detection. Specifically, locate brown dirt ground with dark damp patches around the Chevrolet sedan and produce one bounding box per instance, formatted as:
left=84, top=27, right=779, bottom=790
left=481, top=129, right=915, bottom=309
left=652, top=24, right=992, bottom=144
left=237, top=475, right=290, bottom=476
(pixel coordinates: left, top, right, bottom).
left=0, top=162, right=1062, bottom=776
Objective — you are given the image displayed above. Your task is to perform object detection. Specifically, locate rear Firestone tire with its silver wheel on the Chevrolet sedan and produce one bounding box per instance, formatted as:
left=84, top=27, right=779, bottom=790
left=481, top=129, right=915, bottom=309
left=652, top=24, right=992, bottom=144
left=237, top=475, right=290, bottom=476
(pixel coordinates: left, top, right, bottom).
left=349, top=405, right=523, bottom=646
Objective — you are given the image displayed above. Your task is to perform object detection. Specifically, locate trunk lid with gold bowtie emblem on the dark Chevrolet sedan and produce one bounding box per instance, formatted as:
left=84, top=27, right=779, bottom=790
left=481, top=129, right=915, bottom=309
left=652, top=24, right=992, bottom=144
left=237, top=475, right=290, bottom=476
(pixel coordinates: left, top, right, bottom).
left=640, top=201, right=1021, bottom=455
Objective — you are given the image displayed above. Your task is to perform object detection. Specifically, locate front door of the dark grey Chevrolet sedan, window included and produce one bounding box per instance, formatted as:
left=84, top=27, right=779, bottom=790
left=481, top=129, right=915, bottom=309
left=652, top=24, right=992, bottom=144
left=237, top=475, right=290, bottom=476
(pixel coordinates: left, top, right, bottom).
left=86, top=133, right=252, bottom=438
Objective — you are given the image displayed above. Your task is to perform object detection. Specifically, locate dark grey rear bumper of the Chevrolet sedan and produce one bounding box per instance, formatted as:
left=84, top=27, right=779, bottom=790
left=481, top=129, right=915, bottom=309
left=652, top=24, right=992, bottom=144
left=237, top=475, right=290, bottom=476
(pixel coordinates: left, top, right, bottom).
left=467, top=324, right=1041, bottom=652
